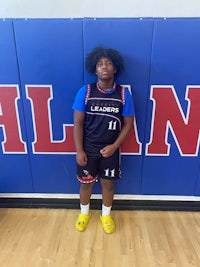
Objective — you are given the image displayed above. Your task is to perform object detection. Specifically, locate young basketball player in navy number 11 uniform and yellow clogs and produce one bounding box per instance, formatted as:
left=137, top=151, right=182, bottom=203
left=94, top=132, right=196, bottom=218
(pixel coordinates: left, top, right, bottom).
left=73, top=47, right=134, bottom=233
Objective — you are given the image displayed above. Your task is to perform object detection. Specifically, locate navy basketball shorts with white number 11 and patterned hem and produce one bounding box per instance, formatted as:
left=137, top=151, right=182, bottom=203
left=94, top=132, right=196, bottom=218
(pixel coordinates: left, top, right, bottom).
left=77, top=149, right=121, bottom=183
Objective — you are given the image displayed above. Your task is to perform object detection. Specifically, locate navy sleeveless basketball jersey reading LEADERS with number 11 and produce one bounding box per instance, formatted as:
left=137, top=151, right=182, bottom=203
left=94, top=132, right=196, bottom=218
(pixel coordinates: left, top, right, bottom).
left=84, top=83, right=125, bottom=153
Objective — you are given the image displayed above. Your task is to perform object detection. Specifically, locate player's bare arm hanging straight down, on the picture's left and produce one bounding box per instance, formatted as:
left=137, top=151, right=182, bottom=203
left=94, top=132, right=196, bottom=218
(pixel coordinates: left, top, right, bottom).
left=74, top=110, right=87, bottom=166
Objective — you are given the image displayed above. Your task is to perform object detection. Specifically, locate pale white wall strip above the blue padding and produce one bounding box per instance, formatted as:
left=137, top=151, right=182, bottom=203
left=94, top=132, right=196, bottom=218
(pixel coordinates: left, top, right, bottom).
left=0, top=0, right=200, bottom=18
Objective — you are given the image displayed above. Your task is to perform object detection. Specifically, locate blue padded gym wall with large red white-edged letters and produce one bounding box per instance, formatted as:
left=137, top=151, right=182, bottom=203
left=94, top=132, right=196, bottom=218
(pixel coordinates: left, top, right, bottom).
left=0, top=18, right=200, bottom=198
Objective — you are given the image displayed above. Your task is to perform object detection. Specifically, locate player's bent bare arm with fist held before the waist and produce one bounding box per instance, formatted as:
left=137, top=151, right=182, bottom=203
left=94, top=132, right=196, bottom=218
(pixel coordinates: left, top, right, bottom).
left=100, top=116, right=134, bottom=157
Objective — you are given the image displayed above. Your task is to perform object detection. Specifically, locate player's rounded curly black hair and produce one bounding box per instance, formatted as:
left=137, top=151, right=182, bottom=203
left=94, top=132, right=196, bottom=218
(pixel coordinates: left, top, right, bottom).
left=85, top=46, right=124, bottom=76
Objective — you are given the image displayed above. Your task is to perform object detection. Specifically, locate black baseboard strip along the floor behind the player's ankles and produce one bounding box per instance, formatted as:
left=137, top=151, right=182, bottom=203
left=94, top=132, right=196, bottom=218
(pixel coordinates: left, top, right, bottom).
left=0, top=198, right=200, bottom=211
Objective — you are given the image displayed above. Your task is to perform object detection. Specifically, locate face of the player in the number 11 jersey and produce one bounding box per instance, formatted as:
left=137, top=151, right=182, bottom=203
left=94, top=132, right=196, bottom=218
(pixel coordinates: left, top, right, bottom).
left=96, top=57, right=116, bottom=80
